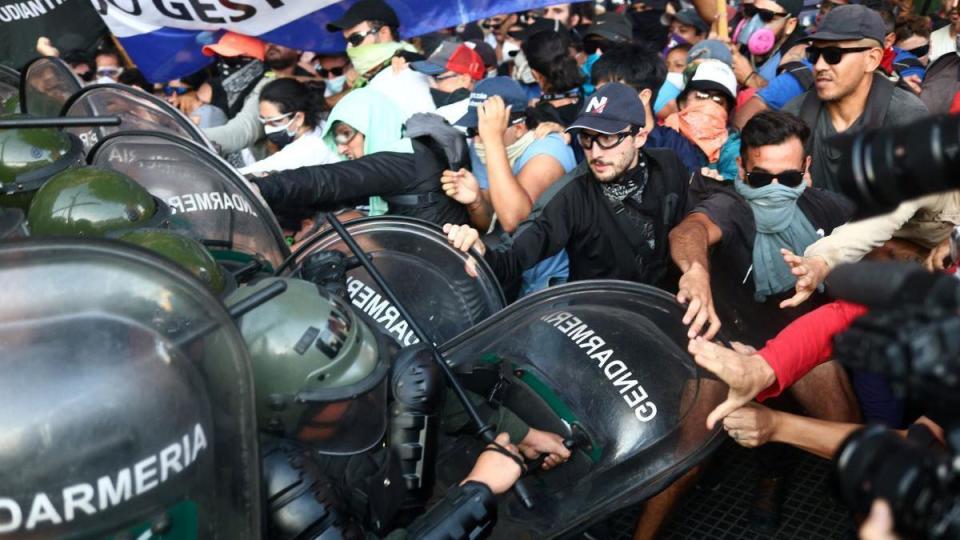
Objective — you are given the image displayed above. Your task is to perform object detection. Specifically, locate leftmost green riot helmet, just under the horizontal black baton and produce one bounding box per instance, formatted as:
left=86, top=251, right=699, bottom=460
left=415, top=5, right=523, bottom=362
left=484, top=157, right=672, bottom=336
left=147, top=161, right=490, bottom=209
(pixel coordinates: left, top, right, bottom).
left=0, top=121, right=83, bottom=211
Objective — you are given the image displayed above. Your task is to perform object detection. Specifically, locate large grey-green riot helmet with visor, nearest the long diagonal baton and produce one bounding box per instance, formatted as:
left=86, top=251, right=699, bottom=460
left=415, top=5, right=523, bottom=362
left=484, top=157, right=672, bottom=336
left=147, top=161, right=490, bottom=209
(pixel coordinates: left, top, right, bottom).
left=226, top=278, right=390, bottom=455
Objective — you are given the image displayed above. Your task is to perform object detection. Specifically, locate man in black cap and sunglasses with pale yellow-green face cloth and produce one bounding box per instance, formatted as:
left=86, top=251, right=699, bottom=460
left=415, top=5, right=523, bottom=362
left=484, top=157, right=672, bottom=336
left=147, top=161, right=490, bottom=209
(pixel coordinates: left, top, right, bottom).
left=327, top=0, right=436, bottom=118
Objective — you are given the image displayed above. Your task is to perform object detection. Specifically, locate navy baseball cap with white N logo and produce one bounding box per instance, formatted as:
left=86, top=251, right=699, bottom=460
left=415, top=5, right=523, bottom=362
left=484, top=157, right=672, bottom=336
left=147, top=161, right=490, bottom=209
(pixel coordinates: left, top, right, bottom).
left=567, top=82, right=647, bottom=134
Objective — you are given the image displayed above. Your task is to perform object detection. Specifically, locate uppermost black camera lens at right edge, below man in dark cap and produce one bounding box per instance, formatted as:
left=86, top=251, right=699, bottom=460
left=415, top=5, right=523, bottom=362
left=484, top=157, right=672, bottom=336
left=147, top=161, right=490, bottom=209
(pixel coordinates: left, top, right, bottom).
left=831, top=115, right=960, bottom=216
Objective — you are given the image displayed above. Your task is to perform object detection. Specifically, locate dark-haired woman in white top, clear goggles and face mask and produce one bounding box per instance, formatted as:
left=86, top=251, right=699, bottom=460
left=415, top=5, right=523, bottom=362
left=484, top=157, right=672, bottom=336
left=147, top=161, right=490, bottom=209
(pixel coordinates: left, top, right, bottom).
left=240, top=78, right=340, bottom=174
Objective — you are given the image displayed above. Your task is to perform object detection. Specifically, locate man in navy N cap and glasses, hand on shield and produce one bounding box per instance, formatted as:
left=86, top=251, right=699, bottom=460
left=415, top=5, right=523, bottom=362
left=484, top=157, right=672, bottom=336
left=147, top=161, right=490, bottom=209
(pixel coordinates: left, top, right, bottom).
left=444, top=83, right=691, bottom=296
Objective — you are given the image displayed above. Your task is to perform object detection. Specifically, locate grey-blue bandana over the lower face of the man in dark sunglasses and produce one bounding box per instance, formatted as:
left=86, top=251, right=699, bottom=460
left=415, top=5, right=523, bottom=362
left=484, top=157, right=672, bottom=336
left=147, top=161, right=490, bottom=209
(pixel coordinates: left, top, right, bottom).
left=734, top=180, right=819, bottom=302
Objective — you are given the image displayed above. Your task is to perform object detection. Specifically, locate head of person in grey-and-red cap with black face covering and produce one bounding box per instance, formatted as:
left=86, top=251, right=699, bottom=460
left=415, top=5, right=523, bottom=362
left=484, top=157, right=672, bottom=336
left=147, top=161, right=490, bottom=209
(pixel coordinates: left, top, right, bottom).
left=410, top=41, right=485, bottom=124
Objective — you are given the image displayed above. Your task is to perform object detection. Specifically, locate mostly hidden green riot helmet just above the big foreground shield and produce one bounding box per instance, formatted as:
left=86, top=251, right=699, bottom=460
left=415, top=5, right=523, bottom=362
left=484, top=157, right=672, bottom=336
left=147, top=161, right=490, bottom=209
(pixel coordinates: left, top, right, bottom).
left=118, top=229, right=236, bottom=296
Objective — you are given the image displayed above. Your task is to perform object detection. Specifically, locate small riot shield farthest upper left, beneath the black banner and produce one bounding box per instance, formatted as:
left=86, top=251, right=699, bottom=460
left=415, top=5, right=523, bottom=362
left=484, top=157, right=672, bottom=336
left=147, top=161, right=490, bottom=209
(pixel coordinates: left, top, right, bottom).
left=20, top=56, right=83, bottom=116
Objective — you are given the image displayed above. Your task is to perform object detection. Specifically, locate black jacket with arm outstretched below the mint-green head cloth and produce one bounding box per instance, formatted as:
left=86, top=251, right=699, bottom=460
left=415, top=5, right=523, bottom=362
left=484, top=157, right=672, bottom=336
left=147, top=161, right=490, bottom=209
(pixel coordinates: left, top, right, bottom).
left=253, top=118, right=470, bottom=225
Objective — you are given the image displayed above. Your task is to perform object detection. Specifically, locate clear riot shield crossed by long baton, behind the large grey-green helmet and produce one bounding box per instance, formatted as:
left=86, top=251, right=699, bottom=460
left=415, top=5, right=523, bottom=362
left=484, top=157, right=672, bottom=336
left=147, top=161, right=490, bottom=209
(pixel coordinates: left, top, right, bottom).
left=280, top=216, right=506, bottom=347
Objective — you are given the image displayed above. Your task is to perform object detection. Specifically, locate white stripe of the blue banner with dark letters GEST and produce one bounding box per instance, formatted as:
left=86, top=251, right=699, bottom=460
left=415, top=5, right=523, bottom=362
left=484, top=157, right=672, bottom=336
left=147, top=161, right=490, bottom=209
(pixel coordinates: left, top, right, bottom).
left=90, top=0, right=341, bottom=37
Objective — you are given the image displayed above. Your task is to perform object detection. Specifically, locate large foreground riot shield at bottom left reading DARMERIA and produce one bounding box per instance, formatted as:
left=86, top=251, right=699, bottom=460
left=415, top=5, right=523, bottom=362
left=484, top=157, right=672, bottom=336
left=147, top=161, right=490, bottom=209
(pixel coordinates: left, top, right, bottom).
left=0, top=239, right=262, bottom=539
